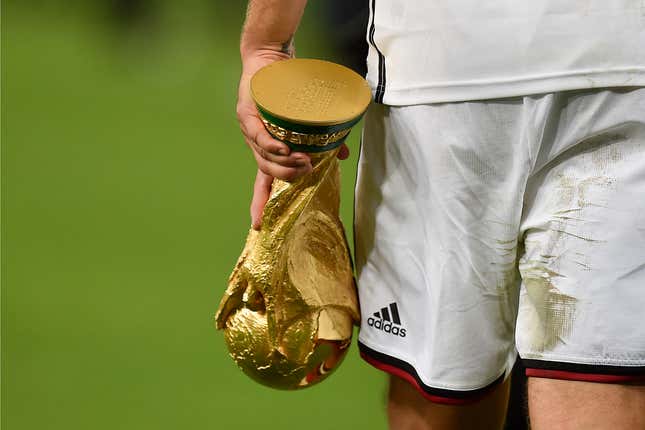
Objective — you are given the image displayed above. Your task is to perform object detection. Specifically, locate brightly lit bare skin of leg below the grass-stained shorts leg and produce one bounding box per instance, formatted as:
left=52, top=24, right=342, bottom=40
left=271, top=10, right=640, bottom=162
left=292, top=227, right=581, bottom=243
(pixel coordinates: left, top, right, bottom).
left=529, top=378, right=645, bottom=430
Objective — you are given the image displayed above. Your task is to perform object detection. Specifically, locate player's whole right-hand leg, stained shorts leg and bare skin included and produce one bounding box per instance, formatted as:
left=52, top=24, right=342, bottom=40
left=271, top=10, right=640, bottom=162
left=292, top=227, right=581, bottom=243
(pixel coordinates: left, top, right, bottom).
left=516, top=89, right=645, bottom=430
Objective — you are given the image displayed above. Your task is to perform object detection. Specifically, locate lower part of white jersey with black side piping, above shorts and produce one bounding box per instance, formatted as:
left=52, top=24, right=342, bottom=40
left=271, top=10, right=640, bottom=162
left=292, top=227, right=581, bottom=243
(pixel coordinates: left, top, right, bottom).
left=367, top=0, right=645, bottom=105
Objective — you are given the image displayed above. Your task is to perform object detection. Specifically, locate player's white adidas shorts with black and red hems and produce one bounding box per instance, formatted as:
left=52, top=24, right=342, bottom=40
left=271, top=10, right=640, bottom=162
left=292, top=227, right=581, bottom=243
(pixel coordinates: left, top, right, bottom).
left=355, top=88, right=645, bottom=403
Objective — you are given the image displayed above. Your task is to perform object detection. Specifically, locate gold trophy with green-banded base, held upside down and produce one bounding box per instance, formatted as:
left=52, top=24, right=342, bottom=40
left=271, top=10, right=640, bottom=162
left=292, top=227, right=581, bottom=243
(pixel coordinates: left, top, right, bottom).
left=215, top=59, right=371, bottom=389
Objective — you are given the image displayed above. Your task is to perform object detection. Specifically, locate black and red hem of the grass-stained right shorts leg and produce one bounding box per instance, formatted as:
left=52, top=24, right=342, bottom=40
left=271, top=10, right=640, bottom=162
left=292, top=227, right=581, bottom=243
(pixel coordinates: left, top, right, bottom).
left=522, top=360, right=645, bottom=384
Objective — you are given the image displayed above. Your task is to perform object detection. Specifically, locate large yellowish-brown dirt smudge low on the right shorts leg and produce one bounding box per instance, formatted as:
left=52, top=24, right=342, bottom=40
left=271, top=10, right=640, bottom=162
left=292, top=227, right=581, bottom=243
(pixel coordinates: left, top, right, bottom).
left=521, top=266, right=577, bottom=352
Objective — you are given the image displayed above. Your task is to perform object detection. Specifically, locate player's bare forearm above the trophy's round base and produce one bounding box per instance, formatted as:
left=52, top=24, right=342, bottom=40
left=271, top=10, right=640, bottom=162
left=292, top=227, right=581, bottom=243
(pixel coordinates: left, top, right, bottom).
left=240, top=0, right=307, bottom=61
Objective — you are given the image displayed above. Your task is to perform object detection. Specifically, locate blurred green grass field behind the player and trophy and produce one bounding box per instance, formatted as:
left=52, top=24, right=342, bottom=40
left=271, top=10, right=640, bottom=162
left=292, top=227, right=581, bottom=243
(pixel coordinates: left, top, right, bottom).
left=2, top=0, right=385, bottom=430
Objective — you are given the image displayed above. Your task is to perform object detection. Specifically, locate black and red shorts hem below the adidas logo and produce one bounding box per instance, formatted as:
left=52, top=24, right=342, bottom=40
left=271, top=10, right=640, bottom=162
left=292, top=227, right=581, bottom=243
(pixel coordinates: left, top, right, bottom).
left=358, top=341, right=505, bottom=405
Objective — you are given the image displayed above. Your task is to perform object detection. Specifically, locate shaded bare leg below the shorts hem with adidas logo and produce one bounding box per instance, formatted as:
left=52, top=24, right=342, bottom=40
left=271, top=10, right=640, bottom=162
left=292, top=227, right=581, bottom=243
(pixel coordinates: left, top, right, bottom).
left=388, top=376, right=510, bottom=430
